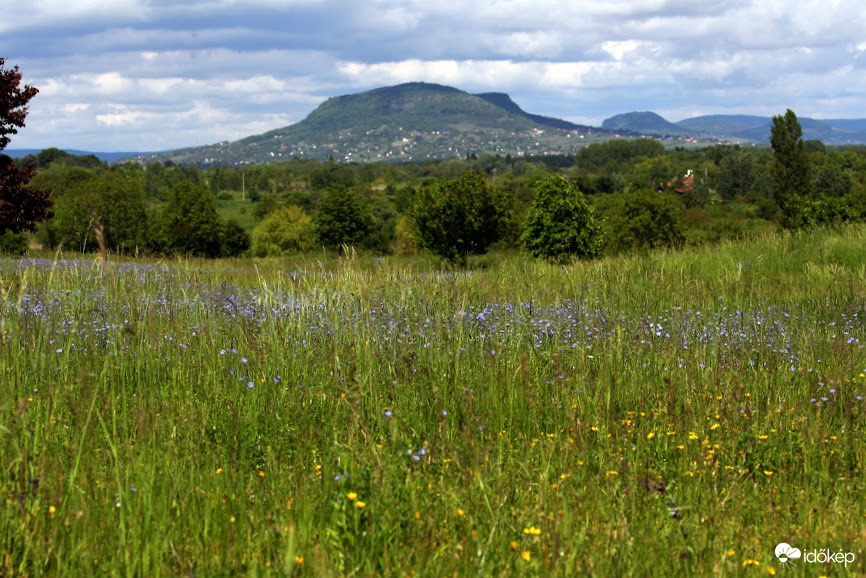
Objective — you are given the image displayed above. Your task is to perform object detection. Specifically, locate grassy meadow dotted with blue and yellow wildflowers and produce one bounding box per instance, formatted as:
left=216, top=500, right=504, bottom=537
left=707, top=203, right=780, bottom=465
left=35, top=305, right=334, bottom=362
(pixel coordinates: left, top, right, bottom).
left=0, top=227, right=866, bottom=577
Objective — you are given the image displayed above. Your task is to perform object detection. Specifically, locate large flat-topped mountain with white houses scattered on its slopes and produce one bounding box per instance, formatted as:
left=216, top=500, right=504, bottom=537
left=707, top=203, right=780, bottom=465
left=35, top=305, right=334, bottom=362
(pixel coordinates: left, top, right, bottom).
left=136, top=82, right=609, bottom=164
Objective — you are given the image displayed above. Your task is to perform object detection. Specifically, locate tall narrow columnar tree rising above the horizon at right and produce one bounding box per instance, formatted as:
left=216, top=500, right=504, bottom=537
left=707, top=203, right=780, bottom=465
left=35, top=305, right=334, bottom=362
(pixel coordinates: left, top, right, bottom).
left=770, top=109, right=812, bottom=229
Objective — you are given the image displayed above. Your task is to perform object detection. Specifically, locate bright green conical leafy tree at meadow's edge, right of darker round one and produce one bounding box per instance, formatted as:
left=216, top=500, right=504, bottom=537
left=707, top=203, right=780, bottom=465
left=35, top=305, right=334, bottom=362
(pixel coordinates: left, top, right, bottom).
left=521, top=175, right=604, bottom=261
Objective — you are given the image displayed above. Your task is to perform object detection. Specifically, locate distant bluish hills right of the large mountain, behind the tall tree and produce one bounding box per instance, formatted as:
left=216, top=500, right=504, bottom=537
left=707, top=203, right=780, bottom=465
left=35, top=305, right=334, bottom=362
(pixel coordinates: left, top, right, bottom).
left=602, top=112, right=866, bottom=145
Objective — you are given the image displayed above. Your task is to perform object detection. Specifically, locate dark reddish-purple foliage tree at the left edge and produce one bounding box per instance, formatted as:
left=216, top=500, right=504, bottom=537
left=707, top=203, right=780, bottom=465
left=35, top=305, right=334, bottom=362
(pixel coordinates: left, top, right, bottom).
left=0, top=58, right=51, bottom=233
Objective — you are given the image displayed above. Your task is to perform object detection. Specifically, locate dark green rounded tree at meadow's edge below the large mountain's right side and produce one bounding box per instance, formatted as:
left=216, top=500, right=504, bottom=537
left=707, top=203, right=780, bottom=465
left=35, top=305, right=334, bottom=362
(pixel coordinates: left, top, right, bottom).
left=412, top=172, right=508, bottom=263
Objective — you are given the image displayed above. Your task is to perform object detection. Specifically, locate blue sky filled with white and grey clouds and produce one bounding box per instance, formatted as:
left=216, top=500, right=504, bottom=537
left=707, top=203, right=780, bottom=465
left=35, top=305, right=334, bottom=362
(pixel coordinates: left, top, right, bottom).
left=0, top=0, right=866, bottom=152
